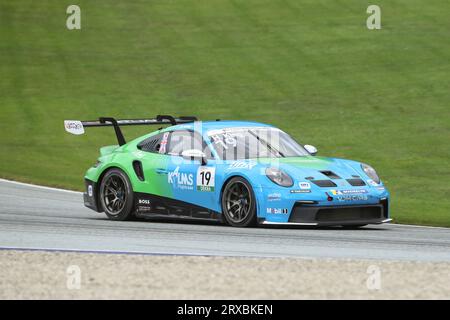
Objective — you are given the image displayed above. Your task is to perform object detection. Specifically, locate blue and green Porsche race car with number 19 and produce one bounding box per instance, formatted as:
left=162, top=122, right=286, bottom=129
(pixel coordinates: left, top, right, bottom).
left=64, top=115, right=391, bottom=228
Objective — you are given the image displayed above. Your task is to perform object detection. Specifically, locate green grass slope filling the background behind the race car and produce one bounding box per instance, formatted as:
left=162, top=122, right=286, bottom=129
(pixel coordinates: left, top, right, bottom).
left=0, top=0, right=450, bottom=226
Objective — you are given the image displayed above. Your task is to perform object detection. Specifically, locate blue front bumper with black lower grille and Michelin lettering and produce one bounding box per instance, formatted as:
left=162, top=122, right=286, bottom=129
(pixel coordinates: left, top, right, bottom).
left=258, top=187, right=391, bottom=226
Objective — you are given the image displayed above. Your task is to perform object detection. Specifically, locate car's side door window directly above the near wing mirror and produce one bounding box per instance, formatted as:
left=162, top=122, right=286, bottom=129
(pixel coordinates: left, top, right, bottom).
left=167, top=130, right=211, bottom=159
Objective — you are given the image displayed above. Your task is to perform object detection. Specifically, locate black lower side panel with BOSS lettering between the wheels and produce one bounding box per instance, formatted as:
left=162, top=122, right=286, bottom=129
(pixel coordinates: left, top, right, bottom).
left=134, top=192, right=223, bottom=222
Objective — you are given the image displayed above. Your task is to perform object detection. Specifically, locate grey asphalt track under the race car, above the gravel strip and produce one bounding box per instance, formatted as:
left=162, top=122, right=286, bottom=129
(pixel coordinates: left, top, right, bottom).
left=0, top=180, right=450, bottom=262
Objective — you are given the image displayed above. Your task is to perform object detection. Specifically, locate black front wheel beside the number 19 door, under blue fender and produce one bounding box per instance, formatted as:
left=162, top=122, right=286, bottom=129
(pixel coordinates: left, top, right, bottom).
left=222, top=177, right=256, bottom=227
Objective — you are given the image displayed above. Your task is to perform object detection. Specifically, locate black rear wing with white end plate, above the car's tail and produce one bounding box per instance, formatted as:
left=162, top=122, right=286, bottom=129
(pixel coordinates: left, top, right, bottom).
left=64, top=115, right=197, bottom=146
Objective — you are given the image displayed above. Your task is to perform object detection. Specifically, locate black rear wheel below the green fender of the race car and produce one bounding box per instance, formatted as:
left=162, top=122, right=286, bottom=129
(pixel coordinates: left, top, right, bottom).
left=100, top=169, right=133, bottom=221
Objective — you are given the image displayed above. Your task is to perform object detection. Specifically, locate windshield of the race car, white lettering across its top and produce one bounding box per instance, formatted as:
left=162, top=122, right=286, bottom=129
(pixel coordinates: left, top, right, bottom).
left=208, top=127, right=309, bottom=160
